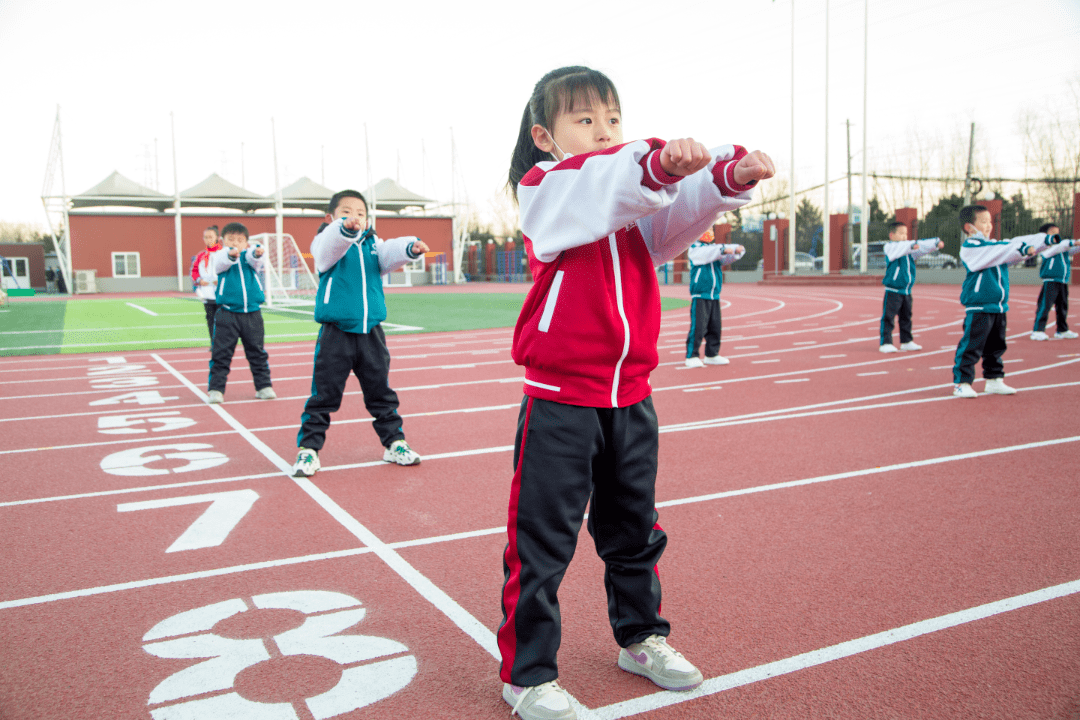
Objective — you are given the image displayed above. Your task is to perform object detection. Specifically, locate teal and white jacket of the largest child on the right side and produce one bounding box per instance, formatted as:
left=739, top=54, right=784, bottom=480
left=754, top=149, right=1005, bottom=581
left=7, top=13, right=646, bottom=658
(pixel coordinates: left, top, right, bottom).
left=960, top=232, right=1061, bottom=313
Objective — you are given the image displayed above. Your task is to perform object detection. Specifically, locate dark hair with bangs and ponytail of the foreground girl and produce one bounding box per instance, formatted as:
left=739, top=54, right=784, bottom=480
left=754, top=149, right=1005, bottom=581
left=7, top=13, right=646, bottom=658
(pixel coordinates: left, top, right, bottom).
left=507, top=65, right=619, bottom=202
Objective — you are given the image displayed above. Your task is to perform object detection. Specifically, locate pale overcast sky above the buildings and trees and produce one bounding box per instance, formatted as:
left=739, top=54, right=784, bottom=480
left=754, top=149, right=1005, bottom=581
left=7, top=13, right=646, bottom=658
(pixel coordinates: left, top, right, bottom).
left=0, top=0, right=1080, bottom=225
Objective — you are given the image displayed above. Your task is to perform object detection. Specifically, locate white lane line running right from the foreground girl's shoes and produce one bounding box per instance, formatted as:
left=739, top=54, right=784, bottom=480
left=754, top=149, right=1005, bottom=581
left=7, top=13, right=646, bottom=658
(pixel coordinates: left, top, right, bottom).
left=580, top=580, right=1080, bottom=720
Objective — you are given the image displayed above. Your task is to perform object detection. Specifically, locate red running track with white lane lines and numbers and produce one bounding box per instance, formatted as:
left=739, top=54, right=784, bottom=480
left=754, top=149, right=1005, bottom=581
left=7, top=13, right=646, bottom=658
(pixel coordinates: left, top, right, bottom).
left=0, top=285, right=1080, bottom=720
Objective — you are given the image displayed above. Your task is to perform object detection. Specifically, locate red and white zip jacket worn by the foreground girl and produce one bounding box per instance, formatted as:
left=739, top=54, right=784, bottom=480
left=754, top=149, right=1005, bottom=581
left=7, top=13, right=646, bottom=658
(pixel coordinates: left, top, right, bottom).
left=513, top=138, right=752, bottom=407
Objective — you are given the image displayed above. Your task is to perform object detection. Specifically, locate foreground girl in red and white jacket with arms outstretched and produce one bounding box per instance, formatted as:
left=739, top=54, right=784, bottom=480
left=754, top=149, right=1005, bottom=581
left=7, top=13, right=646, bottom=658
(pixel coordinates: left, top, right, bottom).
left=498, top=67, right=773, bottom=720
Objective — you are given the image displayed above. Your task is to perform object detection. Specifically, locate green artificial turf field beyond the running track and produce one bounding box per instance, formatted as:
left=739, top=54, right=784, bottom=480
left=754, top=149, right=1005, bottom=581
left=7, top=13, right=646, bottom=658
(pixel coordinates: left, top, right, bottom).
left=0, top=293, right=690, bottom=355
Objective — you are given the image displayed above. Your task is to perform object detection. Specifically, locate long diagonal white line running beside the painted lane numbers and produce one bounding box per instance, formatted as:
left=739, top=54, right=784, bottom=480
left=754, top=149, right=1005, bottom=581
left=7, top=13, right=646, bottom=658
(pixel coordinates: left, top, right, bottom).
left=152, top=353, right=501, bottom=660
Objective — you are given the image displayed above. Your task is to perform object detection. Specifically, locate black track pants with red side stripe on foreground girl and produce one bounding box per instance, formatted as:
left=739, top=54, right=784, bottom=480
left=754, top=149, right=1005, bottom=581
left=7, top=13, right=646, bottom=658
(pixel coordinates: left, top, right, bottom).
left=498, top=397, right=671, bottom=685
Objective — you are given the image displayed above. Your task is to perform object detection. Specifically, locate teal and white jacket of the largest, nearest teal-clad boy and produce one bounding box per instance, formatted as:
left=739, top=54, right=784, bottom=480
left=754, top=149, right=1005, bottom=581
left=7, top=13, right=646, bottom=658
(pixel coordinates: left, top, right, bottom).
left=311, top=218, right=420, bottom=334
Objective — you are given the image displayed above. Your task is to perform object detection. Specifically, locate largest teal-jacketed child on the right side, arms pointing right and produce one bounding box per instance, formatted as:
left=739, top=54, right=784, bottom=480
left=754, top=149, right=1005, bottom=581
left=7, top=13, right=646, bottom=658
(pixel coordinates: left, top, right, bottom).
left=953, top=205, right=1061, bottom=397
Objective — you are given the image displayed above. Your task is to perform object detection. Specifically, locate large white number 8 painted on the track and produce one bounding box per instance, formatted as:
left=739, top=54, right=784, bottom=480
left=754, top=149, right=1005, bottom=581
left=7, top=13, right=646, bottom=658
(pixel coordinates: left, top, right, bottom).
left=143, top=590, right=417, bottom=720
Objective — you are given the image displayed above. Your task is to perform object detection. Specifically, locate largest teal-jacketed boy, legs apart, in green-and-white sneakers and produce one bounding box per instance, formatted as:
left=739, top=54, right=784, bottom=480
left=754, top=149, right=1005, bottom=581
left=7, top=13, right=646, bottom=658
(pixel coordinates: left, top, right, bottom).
left=293, top=190, right=428, bottom=477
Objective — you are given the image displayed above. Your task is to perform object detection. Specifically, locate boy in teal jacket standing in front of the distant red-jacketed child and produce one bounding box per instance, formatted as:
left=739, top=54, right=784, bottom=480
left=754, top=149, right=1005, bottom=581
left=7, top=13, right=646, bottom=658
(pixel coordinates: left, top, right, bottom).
left=206, top=222, right=276, bottom=403
